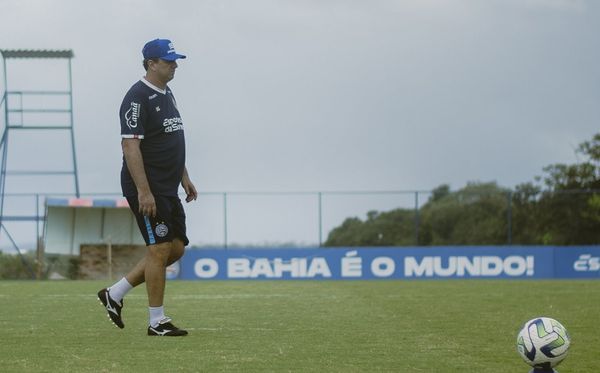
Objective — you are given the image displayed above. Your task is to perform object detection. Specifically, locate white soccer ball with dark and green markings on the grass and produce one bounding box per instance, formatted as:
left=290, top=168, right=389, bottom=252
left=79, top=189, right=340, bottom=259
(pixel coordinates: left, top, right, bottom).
left=517, top=317, right=571, bottom=371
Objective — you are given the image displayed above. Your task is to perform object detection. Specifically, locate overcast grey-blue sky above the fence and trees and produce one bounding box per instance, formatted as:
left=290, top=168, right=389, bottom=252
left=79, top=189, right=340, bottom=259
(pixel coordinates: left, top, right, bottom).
left=0, top=0, right=600, bottom=248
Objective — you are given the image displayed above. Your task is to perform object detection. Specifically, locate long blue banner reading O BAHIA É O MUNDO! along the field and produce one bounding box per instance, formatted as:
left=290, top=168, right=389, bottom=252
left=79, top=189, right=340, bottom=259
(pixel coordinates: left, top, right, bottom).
left=167, top=246, right=600, bottom=280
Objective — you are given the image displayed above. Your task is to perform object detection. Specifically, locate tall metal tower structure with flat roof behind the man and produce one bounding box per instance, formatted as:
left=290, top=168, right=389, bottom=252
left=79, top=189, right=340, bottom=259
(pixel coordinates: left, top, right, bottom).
left=0, top=50, right=79, bottom=276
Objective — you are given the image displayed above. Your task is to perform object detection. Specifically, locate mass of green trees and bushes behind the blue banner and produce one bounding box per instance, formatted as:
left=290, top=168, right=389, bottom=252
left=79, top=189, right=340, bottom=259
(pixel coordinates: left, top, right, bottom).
left=325, top=133, right=600, bottom=246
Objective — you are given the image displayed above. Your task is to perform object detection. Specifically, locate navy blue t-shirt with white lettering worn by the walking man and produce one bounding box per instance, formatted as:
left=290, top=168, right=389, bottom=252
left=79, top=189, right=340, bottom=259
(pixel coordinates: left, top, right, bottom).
left=119, top=78, right=185, bottom=196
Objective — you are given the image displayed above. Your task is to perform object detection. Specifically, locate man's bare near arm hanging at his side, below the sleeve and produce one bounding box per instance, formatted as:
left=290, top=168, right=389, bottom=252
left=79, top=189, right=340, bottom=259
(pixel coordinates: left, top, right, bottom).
left=121, top=139, right=156, bottom=216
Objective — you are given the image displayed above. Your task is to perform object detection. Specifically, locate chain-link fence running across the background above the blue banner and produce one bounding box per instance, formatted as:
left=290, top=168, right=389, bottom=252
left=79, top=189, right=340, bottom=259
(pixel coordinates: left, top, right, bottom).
left=0, top=190, right=600, bottom=253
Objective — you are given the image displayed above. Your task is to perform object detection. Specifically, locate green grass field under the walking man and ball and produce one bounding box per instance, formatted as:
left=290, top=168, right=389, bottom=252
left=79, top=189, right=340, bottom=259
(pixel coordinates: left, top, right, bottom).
left=0, top=280, right=600, bottom=373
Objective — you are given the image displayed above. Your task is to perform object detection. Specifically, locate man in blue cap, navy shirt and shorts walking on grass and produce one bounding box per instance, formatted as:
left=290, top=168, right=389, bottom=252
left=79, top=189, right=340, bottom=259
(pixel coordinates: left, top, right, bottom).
left=98, top=39, right=198, bottom=336
